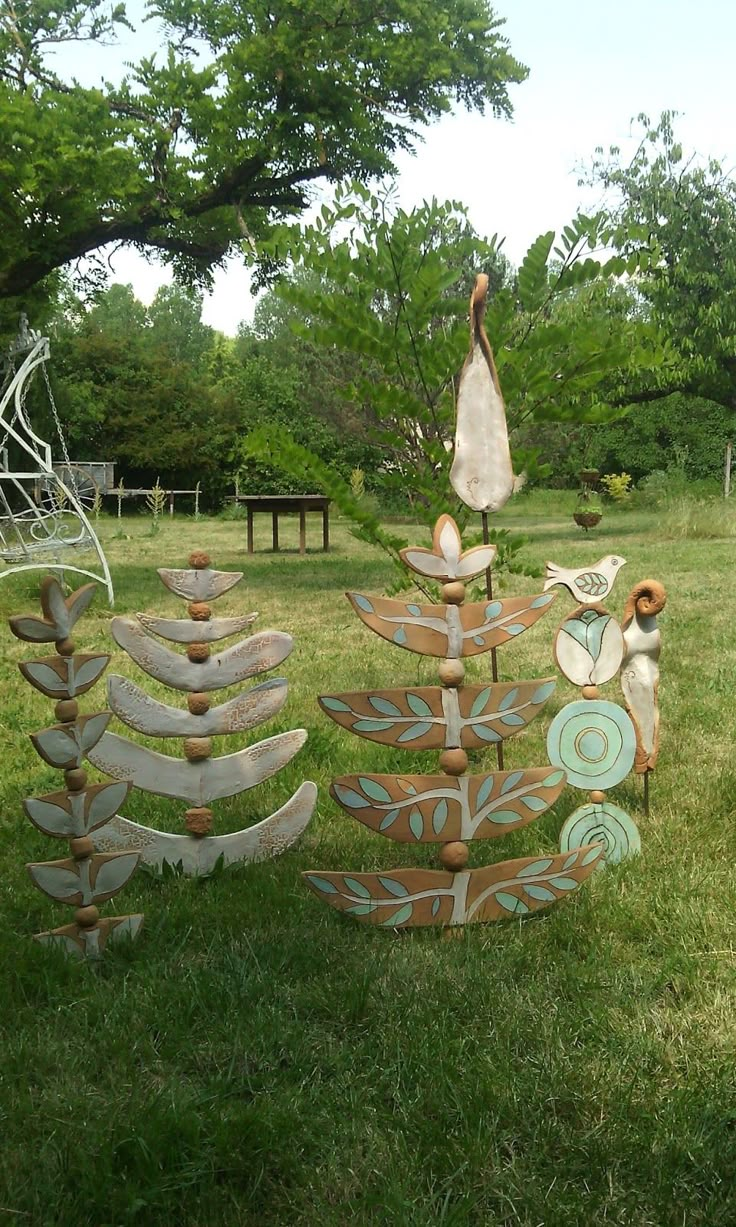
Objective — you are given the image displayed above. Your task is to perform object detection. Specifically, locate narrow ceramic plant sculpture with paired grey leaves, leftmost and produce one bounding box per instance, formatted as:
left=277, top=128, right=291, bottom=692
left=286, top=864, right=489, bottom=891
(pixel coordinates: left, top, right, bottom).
left=10, top=575, right=144, bottom=958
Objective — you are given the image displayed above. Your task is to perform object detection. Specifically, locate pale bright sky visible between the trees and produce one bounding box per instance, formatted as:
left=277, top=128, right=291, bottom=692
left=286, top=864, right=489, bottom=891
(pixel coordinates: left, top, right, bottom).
left=54, top=0, right=736, bottom=334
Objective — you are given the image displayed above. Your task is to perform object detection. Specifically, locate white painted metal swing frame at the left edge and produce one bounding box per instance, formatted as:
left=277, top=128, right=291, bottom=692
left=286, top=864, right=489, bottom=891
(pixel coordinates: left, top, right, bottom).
left=0, top=320, right=113, bottom=605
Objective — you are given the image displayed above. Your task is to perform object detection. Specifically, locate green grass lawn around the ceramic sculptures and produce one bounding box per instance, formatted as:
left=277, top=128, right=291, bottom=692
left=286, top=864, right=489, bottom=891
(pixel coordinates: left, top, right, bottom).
left=0, top=498, right=736, bottom=1227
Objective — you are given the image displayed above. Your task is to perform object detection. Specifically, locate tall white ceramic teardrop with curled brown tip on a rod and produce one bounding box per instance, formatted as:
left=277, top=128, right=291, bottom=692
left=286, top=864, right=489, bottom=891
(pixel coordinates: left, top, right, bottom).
left=450, top=272, right=514, bottom=512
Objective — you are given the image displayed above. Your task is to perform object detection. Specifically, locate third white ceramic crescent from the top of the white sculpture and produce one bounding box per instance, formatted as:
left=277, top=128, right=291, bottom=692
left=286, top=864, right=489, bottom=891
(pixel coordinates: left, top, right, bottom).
left=110, top=623, right=294, bottom=691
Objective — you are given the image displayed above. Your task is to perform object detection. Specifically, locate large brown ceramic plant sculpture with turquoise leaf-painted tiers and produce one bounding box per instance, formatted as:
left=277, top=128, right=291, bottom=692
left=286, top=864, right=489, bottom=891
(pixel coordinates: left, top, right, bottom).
left=304, top=515, right=602, bottom=929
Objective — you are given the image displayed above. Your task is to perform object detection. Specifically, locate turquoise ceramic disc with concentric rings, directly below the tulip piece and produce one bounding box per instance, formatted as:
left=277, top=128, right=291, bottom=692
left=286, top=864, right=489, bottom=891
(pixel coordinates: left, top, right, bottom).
left=547, top=699, right=637, bottom=791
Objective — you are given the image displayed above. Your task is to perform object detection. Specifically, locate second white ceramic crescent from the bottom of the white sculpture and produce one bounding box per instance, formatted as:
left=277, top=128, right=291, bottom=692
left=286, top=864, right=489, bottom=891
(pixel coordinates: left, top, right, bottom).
left=87, top=729, right=307, bottom=805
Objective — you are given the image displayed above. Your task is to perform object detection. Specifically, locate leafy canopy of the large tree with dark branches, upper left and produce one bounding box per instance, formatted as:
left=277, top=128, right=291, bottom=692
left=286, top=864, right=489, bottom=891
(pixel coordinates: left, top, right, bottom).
left=0, top=0, right=526, bottom=298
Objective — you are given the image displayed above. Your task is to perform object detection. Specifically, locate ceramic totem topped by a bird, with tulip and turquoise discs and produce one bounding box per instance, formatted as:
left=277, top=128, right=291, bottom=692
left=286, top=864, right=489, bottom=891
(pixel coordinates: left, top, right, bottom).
left=545, top=571, right=640, bottom=864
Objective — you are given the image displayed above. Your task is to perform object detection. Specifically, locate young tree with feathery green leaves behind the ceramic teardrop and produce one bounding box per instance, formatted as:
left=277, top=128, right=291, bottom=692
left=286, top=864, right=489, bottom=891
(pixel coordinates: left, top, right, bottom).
left=250, top=184, right=661, bottom=579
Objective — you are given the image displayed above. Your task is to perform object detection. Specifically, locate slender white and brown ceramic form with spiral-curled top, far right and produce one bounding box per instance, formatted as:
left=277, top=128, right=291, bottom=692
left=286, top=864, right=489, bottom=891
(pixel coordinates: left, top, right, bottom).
left=621, top=579, right=667, bottom=812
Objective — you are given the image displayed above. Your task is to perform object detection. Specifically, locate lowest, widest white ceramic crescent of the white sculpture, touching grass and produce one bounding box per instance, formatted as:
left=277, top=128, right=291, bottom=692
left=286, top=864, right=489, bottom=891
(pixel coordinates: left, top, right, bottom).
left=89, top=780, right=316, bottom=876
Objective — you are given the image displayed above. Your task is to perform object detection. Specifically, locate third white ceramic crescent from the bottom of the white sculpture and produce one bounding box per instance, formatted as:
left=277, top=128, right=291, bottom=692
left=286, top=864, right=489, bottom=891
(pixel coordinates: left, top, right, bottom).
left=108, top=674, right=288, bottom=737
